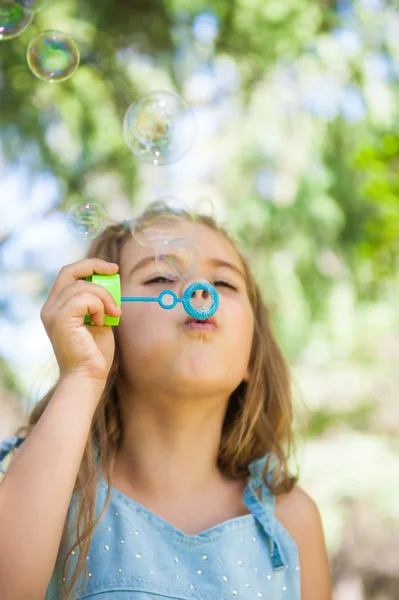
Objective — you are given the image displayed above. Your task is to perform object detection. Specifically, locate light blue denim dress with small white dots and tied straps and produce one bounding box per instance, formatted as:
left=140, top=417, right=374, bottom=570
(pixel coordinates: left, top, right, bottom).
left=0, top=437, right=300, bottom=600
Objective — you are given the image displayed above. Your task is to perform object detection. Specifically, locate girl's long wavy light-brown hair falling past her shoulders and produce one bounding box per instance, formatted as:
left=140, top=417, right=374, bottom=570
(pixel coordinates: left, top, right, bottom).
left=17, top=203, right=298, bottom=600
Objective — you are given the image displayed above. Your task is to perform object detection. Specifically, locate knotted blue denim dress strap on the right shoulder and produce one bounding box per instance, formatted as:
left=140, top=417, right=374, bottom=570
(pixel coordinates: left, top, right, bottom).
left=243, top=454, right=287, bottom=571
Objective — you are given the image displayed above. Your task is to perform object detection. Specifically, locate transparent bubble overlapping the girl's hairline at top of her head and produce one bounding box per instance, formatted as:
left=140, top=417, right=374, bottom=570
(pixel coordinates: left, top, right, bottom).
left=130, top=196, right=195, bottom=246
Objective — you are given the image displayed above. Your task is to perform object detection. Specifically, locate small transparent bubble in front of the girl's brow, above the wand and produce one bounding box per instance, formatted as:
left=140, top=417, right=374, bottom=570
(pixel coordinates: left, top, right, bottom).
left=155, top=238, right=198, bottom=281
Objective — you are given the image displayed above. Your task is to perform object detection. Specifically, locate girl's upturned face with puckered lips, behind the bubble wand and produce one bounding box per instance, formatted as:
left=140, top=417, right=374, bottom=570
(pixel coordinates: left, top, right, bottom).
left=118, top=224, right=254, bottom=397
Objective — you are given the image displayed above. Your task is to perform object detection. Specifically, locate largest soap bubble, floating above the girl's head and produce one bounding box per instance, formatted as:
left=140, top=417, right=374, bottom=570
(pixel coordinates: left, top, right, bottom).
left=123, top=92, right=197, bottom=165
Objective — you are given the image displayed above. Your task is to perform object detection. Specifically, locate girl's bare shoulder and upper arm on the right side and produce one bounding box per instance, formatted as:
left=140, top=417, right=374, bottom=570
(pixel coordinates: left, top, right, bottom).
left=275, top=485, right=331, bottom=600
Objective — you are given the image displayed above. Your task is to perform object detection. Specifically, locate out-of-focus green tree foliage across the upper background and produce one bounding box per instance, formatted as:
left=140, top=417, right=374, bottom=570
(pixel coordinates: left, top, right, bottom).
left=0, top=0, right=399, bottom=358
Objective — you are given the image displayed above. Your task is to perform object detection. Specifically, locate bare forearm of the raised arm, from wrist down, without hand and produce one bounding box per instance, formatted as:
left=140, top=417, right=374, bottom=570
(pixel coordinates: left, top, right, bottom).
left=0, top=378, right=102, bottom=600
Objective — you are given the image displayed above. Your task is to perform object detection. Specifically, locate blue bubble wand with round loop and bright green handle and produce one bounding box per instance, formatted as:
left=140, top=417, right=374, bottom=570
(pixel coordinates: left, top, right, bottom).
left=84, top=274, right=219, bottom=325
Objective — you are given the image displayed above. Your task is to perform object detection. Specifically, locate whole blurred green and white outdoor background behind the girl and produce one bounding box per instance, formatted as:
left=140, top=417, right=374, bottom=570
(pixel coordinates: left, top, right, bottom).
left=0, top=0, right=399, bottom=600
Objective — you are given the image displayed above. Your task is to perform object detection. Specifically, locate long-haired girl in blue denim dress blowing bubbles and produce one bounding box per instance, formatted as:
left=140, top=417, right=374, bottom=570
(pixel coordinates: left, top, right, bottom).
left=0, top=205, right=331, bottom=600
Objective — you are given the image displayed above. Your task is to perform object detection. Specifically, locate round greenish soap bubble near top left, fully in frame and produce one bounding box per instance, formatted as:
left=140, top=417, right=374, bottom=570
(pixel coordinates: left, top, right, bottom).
left=27, top=30, right=80, bottom=83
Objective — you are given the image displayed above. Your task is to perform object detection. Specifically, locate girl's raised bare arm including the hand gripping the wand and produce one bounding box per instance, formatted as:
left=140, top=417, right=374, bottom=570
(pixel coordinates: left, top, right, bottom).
left=0, top=258, right=120, bottom=600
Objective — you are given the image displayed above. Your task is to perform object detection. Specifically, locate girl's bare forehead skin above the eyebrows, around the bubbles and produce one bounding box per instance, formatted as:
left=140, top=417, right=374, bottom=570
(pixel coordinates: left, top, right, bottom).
left=120, top=223, right=243, bottom=268
